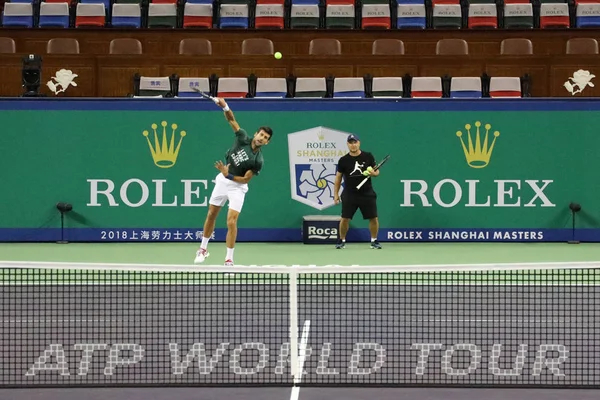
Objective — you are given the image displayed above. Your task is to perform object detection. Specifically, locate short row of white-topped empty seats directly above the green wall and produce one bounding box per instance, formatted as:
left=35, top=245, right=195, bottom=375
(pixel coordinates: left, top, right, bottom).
left=133, top=75, right=529, bottom=98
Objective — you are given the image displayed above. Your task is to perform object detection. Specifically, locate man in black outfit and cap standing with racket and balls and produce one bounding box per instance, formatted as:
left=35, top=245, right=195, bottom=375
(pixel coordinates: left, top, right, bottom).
left=333, top=135, right=381, bottom=249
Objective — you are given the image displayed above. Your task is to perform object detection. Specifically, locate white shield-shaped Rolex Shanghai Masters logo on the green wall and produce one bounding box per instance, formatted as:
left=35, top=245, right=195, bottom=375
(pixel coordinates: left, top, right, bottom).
left=288, top=126, right=350, bottom=210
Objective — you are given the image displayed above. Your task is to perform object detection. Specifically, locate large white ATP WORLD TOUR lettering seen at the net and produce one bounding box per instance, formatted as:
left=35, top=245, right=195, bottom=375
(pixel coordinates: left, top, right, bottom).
left=25, top=342, right=569, bottom=381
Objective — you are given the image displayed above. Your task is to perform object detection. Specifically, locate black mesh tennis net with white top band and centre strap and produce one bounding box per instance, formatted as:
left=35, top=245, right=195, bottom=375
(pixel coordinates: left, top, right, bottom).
left=0, top=262, right=600, bottom=388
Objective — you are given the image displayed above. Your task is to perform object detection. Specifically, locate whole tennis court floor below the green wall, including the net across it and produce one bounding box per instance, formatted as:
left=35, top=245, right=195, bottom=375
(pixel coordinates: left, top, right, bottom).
left=0, top=243, right=600, bottom=400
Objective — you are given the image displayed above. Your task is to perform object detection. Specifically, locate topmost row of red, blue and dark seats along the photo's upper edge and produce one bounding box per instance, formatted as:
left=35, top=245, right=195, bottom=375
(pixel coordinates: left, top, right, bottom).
left=2, top=0, right=600, bottom=29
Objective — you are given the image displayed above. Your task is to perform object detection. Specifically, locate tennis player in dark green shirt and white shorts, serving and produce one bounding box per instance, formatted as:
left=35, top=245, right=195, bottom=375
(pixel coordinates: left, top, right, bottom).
left=194, top=97, right=273, bottom=266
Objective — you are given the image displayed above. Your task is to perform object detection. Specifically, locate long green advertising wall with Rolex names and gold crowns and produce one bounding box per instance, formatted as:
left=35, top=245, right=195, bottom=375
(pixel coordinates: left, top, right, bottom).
left=0, top=99, right=600, bottom=241
